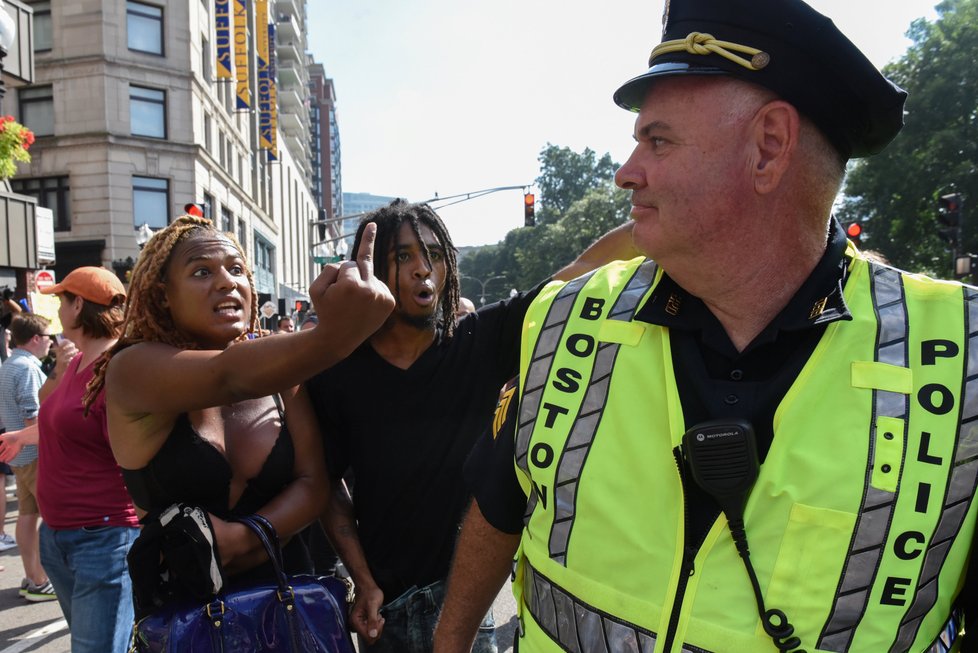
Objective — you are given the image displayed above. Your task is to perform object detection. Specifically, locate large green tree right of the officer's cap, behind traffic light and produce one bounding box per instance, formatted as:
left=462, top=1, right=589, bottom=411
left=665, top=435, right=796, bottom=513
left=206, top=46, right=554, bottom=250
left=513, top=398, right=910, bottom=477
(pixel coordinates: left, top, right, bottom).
left=839, top=0, right=978, bottom=277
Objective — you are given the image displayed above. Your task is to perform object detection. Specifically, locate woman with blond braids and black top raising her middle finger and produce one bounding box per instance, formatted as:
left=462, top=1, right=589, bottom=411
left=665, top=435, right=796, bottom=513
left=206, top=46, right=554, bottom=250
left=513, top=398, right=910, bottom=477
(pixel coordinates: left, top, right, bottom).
left=85, top=216, right=393, bottom=619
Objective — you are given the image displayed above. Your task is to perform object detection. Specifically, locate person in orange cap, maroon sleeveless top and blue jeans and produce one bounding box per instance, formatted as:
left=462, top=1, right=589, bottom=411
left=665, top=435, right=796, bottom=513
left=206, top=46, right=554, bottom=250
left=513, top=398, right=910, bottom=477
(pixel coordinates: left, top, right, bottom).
left=0, top=267, right=133, bottom=653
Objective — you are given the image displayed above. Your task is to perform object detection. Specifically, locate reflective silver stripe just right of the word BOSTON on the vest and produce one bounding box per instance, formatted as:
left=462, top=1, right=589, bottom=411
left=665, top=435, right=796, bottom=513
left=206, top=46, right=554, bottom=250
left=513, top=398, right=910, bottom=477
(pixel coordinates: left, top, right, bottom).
left=549, top=261, right=656, bottom=565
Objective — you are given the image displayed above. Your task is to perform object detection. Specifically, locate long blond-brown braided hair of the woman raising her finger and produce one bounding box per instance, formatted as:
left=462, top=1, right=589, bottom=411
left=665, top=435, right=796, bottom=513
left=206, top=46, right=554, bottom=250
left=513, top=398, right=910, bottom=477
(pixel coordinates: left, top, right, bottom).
left=82, top=215, right=259, bottom=413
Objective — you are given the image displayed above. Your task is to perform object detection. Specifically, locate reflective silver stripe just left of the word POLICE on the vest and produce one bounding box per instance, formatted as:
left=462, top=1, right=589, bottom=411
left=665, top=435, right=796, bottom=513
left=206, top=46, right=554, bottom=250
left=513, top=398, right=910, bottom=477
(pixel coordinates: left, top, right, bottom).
left=816, top=263, right=910, bottom=653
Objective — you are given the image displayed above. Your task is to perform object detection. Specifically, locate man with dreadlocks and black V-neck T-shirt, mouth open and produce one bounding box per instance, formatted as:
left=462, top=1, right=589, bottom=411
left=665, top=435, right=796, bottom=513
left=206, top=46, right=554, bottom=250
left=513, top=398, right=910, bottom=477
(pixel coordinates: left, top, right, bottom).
left=307, top=200, right=635, bottom=653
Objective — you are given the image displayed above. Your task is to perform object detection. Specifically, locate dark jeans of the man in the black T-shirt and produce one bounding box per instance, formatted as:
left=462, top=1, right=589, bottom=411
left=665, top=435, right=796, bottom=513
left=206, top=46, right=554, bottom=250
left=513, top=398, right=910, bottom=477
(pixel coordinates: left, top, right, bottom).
left=359, top=581, right=496, bottom=653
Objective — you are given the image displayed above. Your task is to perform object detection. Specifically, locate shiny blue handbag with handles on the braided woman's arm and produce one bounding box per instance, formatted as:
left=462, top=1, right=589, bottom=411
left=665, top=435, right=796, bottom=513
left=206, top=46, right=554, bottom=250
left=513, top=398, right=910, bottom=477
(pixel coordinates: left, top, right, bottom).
left=129, top=515, right=354, bottom=653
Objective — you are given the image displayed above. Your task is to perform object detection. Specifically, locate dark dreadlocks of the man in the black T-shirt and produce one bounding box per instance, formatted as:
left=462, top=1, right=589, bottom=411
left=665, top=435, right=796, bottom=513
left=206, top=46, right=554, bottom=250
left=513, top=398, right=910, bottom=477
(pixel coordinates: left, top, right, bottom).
left=353, top=198, right=460, bottom=338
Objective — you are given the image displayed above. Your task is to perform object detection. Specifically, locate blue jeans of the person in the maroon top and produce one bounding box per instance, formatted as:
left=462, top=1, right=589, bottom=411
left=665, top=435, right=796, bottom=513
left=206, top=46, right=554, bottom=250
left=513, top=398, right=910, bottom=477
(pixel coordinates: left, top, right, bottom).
left=40, top=523, right=139, bottom=653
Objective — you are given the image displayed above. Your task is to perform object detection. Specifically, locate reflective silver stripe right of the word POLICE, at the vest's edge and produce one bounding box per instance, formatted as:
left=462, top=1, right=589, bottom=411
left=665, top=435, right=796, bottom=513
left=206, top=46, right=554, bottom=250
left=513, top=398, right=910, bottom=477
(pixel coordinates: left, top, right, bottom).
left=890, top=287, right=978, bottom=653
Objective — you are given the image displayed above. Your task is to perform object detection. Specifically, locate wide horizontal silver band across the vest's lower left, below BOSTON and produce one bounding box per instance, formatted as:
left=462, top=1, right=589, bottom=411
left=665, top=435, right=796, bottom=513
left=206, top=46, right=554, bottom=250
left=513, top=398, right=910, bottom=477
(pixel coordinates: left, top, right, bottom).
left=524, top=563, right=660, bottom=653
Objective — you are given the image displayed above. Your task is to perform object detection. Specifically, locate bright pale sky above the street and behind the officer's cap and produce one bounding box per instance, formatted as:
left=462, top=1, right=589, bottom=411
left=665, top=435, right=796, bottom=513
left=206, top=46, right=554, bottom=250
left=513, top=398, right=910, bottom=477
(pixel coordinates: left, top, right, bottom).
left=307, top=0, right=936, bottom=246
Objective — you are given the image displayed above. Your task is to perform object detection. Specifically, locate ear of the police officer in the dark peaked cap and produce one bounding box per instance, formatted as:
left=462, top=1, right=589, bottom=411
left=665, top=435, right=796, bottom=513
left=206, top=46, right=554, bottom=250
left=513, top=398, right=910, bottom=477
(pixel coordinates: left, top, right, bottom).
left=751, top=100, right=801, bottom=195
